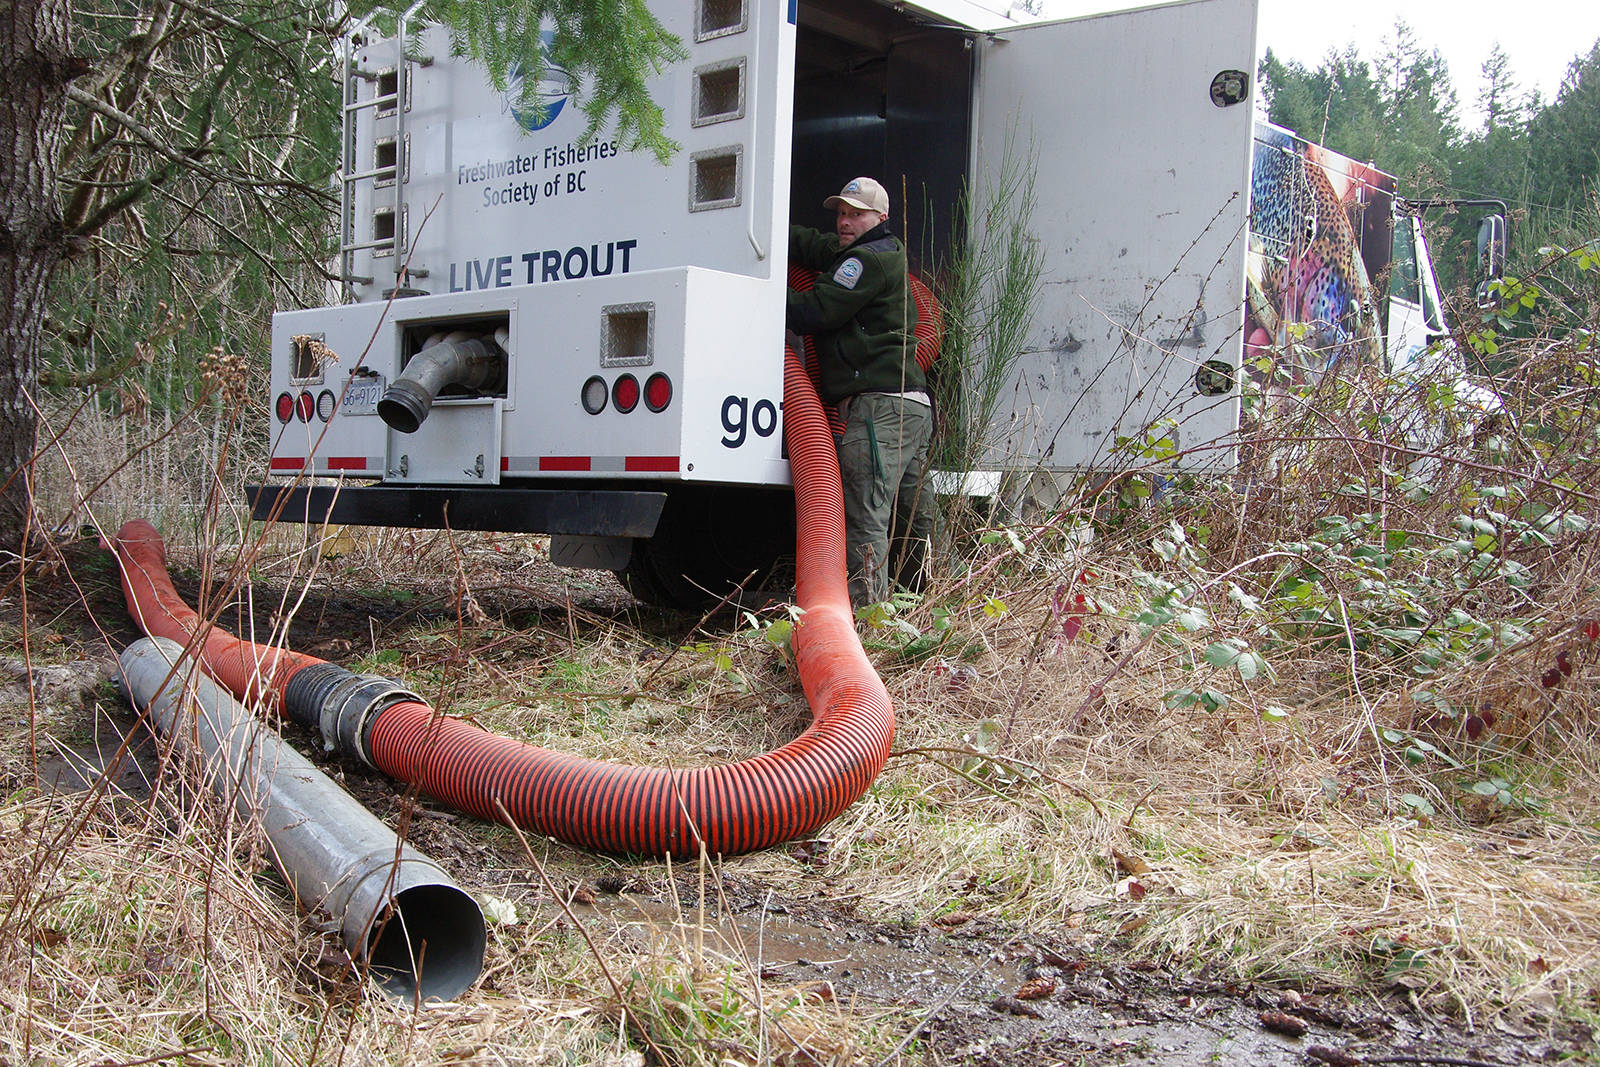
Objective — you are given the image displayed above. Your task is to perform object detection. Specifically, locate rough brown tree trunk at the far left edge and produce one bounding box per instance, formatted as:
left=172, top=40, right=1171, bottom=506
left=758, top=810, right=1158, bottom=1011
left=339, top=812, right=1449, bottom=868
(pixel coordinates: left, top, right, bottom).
left=0, top=0, right=75, bottom=552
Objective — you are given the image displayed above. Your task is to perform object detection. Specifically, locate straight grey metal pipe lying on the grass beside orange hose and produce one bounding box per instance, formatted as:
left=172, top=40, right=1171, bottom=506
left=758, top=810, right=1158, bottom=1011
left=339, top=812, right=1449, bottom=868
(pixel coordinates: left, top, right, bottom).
left=120, top=637, right=485, bottom=1001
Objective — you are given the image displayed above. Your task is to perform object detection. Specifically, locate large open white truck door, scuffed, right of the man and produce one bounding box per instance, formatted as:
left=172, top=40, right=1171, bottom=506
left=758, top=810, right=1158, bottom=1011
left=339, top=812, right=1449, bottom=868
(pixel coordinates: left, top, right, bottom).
left=973, top=0, right=1256, bottom=470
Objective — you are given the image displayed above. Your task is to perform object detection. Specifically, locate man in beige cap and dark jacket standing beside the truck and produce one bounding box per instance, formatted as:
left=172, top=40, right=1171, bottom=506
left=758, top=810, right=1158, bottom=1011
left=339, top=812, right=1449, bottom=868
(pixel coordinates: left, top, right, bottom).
left=786, top=178, right=933, bottom=606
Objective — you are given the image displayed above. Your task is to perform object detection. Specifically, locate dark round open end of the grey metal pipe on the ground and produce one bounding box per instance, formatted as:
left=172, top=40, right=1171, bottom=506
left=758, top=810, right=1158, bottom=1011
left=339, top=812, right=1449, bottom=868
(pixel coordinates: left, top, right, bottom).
left=366, top=885, right=488, bottom=1003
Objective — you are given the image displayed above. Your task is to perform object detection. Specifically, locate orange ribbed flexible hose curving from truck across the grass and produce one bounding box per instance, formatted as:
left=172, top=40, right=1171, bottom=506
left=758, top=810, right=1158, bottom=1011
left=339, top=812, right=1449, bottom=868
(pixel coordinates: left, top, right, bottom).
left=112, top=352, right=894, bottom=857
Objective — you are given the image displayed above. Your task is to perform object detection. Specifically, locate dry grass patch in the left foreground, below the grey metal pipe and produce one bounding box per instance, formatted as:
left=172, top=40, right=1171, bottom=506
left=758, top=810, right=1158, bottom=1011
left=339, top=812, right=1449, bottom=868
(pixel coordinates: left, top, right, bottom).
left=0, top=755, right=862, bottom=1067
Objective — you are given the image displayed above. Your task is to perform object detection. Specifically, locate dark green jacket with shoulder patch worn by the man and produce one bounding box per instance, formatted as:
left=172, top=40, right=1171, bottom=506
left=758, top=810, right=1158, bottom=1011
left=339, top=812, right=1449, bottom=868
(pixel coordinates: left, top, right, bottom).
left=786, top=224, right=928, bottom=403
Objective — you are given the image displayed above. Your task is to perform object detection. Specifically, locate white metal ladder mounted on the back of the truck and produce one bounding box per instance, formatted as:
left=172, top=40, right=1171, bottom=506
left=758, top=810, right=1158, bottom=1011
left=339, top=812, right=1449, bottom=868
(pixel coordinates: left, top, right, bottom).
left=339, top=0, right=434, bottom=304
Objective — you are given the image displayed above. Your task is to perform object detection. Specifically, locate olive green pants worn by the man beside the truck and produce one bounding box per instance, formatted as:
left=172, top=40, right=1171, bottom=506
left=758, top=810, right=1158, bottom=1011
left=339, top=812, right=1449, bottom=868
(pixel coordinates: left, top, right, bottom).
left=837, top=394, right=936, bottom=608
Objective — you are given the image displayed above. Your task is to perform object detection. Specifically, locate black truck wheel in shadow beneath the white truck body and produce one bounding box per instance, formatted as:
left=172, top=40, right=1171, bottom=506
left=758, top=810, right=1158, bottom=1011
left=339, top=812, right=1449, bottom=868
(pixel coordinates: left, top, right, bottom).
left=619, top=486, right=795, bottom=611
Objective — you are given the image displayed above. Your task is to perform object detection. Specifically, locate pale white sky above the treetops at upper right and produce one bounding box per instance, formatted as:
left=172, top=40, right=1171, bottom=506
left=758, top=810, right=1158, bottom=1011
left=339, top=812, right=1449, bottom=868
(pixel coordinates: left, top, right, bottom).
left=1256, top=0, right=1600, bottom=126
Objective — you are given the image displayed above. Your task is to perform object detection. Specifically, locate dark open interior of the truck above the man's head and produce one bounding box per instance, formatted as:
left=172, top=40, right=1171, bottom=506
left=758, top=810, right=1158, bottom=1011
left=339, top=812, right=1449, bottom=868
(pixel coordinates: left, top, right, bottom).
left=789, top=0, right=973, bottom=274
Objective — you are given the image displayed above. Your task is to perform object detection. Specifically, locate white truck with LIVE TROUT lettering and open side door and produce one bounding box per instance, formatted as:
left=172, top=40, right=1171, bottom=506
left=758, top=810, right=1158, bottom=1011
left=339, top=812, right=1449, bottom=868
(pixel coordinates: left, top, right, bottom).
left=251, top=0, right=1504, bottom=605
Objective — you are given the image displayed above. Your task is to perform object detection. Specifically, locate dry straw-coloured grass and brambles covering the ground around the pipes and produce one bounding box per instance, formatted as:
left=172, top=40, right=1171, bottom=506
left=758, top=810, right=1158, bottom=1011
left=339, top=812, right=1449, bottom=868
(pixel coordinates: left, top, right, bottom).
left=9, top=313, right=1600, bottom=1065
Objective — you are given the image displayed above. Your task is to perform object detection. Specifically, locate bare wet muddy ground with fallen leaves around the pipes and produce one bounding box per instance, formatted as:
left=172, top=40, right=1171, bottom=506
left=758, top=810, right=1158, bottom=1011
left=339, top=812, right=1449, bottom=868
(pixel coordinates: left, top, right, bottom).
left=0, top=542, right=1595, bottom=1067
